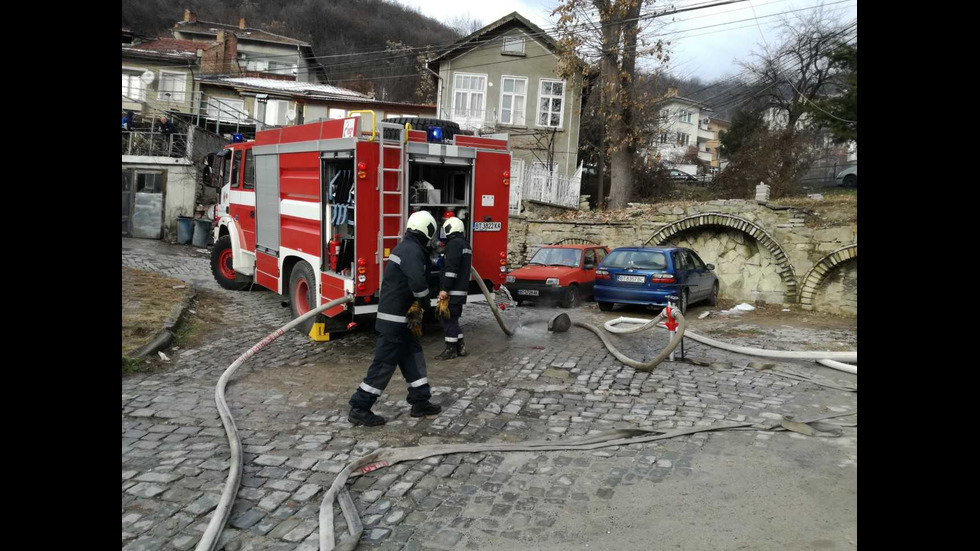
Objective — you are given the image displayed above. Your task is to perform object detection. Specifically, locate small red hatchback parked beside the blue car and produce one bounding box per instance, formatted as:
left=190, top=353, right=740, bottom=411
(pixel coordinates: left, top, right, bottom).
left=504, top=245, right=609, bottom=308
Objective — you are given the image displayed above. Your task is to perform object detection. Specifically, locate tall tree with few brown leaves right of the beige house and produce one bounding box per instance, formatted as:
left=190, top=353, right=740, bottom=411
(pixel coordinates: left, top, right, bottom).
left=552, top=0, right=668, bottom=209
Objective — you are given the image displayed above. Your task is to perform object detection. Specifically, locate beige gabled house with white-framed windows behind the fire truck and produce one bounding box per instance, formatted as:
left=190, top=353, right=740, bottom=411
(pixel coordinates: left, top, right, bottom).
left=429, top=12, right=582, bottom=207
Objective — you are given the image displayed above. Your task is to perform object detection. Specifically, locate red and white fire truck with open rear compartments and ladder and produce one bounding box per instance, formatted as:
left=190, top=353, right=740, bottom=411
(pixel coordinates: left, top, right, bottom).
left=211, top=111, right=510, bottom=338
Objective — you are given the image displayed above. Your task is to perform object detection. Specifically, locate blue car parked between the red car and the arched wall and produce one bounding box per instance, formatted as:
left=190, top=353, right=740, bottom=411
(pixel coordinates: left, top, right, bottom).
left=594, top=247, right=718, bottom=313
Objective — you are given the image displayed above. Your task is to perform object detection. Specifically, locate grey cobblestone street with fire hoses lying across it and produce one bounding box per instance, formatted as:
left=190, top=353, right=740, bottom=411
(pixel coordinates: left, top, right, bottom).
left=122, top=239, right=857, bottom=551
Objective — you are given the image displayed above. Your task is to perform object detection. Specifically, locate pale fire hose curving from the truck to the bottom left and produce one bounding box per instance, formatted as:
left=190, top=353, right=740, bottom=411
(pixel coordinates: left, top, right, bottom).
left=194, top=296, right=353, bottom=551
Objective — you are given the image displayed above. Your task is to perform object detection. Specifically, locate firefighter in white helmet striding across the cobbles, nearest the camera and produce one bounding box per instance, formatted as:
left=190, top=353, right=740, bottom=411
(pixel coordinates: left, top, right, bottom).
left=347, top=211, right=442, bottom=426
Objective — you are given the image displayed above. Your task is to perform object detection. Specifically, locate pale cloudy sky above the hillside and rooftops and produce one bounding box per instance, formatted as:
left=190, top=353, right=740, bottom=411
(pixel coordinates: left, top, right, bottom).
left=396, top=0, right=857, bottom=81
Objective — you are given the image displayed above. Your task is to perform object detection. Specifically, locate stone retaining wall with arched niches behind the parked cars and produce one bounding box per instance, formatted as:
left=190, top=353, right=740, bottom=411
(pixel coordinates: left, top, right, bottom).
left=508, top=200, right=857, bottom=314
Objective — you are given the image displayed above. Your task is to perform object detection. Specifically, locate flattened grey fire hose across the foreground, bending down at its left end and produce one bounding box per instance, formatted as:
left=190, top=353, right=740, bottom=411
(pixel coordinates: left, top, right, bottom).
left=318, top=411, right=857, bottom=551
